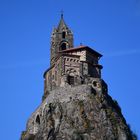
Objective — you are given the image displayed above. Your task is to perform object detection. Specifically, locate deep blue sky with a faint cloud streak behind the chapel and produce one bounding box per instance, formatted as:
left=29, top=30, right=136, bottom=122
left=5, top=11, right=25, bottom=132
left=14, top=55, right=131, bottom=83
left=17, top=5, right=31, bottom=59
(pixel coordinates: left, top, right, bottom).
left=0, top=0, right=140, bottom=140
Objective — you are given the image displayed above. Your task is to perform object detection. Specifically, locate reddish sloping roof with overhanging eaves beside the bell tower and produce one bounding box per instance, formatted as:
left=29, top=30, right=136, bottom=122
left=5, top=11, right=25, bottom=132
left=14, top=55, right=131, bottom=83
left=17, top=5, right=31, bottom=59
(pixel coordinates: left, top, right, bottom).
left=59, top=46, right=102, bottom=57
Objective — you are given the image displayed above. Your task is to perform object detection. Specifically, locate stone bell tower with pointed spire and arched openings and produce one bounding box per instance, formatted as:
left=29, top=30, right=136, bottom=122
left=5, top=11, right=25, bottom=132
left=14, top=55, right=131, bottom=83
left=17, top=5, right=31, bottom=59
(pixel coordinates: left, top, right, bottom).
left=50, top=14, right=73, bottom=66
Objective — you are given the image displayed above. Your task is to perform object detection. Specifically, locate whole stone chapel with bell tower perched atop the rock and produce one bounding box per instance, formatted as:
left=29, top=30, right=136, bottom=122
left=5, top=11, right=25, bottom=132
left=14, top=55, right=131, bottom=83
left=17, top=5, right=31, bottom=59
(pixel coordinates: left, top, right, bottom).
left=44, top=15, right=102, bottom=98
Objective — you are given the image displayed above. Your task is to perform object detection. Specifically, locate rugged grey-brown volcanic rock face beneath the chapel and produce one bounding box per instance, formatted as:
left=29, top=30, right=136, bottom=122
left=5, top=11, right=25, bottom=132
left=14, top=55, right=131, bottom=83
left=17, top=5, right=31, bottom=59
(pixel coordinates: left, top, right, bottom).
left=21, top=85, right=135, bottom=140
